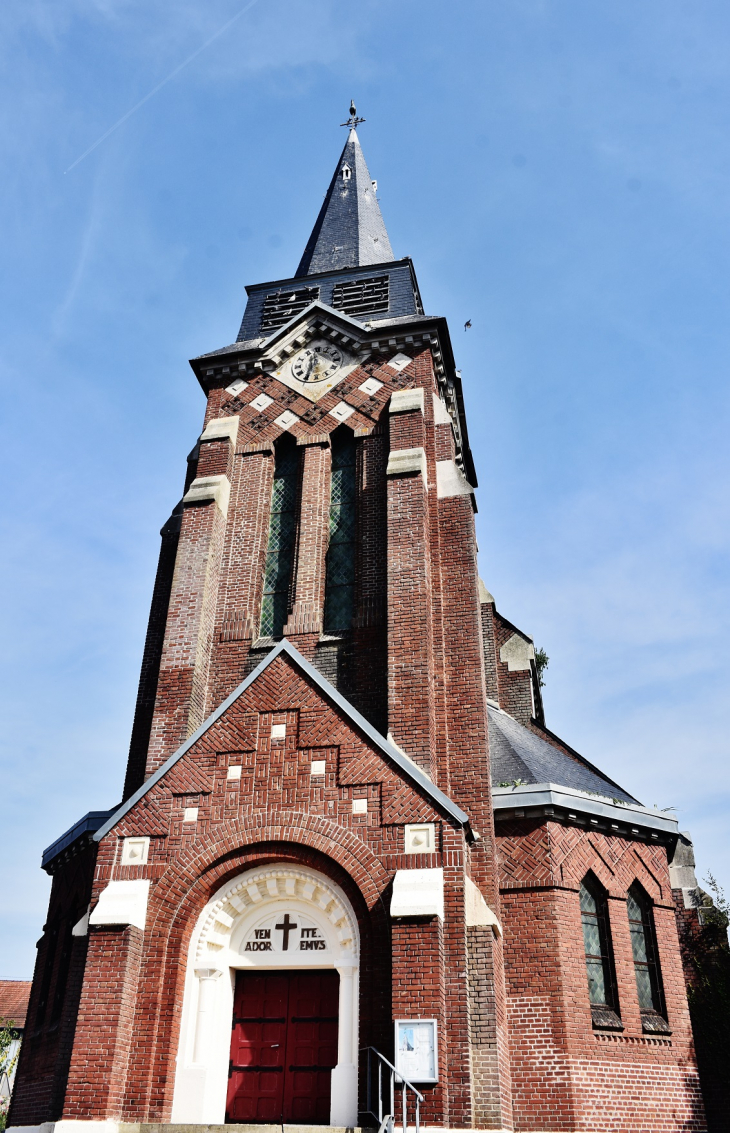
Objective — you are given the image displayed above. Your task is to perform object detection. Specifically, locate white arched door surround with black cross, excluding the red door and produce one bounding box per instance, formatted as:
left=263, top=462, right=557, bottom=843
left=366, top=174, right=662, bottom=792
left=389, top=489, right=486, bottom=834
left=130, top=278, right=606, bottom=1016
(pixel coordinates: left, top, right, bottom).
left=171, top=863, right=359, bottom=1126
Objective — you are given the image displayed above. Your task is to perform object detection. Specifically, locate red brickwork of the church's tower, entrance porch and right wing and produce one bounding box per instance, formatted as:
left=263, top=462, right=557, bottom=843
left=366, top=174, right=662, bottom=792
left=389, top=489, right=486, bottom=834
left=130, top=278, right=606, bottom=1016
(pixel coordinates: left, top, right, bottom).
left=11, top=290, right=704, bottom=1133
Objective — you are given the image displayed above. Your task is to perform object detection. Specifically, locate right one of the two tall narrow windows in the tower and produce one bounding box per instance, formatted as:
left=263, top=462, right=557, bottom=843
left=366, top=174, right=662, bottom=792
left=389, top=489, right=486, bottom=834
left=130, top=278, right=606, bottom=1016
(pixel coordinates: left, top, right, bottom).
left=324, top=428, right=355, bottom=633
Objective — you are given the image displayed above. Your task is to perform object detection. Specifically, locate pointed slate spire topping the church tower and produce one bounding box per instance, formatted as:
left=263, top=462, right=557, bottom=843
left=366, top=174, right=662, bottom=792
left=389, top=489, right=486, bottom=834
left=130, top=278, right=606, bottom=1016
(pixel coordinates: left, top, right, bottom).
left=297, top=129, right=394, bottom=276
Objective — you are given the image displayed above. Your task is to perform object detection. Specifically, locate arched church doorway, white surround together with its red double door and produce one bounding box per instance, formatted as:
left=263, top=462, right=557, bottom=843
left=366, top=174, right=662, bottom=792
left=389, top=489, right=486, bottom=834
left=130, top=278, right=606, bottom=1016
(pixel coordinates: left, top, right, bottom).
left=172, top=863, right=359, bottom=1126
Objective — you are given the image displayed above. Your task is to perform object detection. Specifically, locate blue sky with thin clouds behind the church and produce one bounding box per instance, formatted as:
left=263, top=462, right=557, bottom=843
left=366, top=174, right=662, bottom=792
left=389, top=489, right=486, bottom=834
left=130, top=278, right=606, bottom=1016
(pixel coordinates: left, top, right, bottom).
left=0, top=0, right=730, bottom=978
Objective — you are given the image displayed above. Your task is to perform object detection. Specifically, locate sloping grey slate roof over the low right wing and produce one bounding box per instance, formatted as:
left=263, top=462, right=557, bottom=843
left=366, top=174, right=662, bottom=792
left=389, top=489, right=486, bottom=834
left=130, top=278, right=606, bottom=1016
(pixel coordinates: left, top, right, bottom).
left=487, top=705, right=638, bottom=803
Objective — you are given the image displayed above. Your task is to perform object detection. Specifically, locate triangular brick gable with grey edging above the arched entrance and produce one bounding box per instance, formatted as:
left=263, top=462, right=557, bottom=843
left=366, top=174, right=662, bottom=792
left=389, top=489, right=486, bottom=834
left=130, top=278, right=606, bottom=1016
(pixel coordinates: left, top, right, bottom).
left=94, top=641, right=468, bottom=842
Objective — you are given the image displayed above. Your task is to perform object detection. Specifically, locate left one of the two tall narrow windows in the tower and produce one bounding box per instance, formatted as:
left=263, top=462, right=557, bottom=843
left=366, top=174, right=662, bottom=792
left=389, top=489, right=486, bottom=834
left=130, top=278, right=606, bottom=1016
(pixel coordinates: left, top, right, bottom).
left=260, top=436, right=299, bottom=637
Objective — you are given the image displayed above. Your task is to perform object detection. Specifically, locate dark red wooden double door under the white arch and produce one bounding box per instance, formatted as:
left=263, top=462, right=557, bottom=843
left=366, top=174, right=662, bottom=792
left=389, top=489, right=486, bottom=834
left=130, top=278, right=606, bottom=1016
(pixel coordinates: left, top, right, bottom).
left=226, top=971, right=339, bottom=1125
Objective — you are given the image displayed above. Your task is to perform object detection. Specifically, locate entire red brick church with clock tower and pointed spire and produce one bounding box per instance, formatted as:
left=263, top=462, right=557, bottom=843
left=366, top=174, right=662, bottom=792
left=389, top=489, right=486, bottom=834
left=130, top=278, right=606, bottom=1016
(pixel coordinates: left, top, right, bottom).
left=8, top=117, right=705, bottom=1133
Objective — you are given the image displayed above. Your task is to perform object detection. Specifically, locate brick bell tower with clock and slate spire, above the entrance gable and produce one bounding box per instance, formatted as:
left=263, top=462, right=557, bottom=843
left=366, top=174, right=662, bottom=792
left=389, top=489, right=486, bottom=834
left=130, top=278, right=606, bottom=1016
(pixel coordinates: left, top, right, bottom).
left=125, top=117, right=489, bottom=823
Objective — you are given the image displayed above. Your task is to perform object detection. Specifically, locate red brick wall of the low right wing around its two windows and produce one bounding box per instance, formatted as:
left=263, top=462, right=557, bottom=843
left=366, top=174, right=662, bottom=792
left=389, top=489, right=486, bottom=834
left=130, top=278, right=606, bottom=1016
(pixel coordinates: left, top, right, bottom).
left=498, top=819, right=706, bottom=1133
